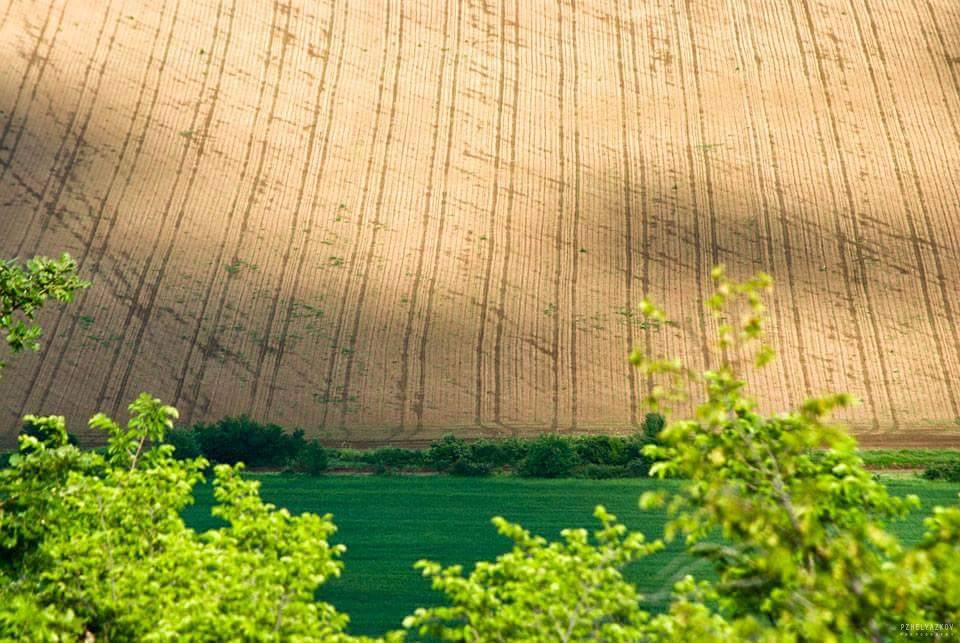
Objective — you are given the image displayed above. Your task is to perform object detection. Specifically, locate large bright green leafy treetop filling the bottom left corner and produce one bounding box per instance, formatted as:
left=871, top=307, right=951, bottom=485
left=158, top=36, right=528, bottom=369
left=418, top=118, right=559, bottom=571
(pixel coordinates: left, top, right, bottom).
left=0, top=395, right=372, bottom=641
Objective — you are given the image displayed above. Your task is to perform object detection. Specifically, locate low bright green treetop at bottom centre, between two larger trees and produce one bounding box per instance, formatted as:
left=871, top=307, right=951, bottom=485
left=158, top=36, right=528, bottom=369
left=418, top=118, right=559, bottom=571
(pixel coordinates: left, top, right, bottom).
left=404, top=507, right=661, bottom=641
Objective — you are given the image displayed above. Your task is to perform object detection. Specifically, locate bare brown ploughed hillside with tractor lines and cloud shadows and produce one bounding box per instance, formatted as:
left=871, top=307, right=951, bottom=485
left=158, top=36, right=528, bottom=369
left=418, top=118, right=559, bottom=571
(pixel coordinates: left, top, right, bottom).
left=0, top=0, right=960, bottom=446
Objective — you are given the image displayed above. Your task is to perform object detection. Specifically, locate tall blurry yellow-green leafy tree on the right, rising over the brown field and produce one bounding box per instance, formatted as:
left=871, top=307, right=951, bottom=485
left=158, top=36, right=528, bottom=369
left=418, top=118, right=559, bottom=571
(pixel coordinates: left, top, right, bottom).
left=640, top=269, right=960, bottom=641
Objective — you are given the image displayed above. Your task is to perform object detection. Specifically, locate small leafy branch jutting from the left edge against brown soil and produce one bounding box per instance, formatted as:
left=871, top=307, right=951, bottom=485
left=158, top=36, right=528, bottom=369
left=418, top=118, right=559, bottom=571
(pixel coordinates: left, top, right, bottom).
left=0, top=254, right=90, bottom=370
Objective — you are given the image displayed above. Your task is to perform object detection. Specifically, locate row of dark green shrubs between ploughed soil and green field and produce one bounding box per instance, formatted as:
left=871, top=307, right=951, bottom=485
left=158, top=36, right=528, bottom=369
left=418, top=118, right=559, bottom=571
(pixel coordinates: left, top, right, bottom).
left=159, top=413, right=664, bottom=478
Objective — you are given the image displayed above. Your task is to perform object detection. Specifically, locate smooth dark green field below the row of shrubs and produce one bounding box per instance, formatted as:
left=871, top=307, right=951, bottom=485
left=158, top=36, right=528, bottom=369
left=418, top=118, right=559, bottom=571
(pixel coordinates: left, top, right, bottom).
left=185, top=475, right=960, bottom=634
